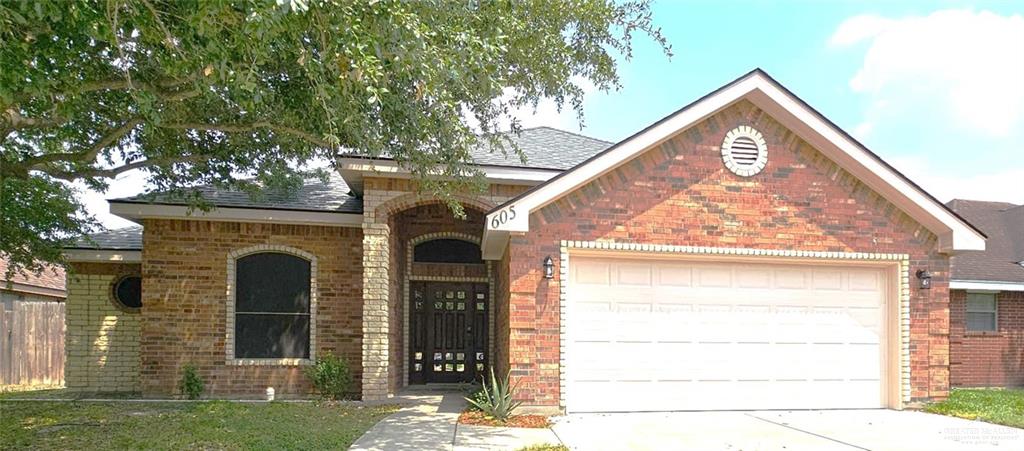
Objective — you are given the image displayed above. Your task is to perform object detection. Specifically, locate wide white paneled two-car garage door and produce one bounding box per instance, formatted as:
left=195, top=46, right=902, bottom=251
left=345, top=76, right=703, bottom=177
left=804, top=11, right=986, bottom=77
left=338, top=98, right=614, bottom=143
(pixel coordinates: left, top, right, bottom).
left=565, top=256, right=886, bottom=412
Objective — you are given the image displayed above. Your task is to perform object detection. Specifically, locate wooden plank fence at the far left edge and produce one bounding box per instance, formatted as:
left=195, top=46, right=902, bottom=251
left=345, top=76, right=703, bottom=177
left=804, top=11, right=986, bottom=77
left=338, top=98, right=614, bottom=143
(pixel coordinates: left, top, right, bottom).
left=0, top=299, right=65, bottom=385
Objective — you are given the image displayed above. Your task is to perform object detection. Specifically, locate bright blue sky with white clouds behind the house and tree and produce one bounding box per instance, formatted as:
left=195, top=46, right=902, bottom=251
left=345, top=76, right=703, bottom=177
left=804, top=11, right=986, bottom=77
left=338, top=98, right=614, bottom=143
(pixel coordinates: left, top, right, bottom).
left=85, top=0, right=1024, bottom=227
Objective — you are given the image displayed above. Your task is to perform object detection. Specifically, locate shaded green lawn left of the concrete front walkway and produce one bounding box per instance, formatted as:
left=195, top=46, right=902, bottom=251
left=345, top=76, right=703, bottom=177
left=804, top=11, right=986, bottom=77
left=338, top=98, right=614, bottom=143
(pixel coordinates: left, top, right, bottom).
left=0, top=401, right=397, bottom=450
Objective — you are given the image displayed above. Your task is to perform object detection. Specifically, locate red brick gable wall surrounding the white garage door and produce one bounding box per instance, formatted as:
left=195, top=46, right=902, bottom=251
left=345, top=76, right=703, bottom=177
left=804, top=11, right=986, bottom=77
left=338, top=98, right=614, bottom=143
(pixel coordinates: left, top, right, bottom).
left=508, top=100, right=949, bottom=406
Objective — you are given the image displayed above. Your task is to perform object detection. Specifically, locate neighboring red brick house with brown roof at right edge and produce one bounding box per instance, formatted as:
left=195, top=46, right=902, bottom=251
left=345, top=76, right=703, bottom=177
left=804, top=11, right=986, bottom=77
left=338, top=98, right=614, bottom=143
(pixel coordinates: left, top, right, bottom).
left=947, top=199, right=1024, bottom=386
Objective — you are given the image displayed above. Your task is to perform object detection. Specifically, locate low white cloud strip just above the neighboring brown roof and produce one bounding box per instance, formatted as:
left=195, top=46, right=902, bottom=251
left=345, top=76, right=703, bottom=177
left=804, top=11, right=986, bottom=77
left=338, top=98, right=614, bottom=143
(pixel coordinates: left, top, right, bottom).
left=889, top=157, right=1024, bottom=204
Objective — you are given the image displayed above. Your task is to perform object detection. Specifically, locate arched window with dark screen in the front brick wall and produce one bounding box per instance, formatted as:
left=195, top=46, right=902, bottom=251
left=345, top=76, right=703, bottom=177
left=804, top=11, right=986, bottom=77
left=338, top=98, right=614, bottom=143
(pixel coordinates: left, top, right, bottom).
left=234, top=252, right=310, bottom=359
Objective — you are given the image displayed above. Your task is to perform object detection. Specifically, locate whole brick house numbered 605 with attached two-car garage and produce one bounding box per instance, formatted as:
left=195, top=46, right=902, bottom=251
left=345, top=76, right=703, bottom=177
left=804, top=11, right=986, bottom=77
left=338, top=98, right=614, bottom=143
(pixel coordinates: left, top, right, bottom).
left=61, top=71, right=985, bottom=411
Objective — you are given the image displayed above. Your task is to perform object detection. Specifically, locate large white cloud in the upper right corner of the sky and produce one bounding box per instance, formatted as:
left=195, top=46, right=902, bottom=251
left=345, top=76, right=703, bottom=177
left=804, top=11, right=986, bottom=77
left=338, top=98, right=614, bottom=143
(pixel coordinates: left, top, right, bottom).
left=829, top=9, right=1024, bottom=137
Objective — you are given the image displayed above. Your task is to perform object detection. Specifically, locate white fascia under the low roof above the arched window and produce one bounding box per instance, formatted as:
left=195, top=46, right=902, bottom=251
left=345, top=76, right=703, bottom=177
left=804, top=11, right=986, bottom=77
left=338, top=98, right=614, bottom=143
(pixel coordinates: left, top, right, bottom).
left=111, top=202, right=362, bottom=228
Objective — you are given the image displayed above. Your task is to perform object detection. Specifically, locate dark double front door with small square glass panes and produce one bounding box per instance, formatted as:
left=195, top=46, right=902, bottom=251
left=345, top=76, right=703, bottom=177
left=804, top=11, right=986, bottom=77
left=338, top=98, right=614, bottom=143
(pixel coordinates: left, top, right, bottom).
left=409, top=282, right=490, bottom=383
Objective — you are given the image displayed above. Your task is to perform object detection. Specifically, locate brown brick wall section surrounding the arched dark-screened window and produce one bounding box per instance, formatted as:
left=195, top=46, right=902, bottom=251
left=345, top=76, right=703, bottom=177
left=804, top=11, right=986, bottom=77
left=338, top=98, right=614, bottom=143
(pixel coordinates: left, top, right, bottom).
left=140, top=220, right=362, bottom=397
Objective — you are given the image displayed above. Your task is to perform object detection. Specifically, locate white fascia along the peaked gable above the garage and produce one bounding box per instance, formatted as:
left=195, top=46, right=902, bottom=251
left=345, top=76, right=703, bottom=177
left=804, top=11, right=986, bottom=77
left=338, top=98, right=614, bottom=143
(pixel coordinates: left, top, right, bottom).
left=485, top=73, right=985, bottom=252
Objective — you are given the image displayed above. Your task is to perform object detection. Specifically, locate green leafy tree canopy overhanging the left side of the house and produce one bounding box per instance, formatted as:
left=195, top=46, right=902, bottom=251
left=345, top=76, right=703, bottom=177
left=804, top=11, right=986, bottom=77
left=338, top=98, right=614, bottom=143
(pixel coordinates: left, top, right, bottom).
left=0, top=0, right=668, bottom=264
